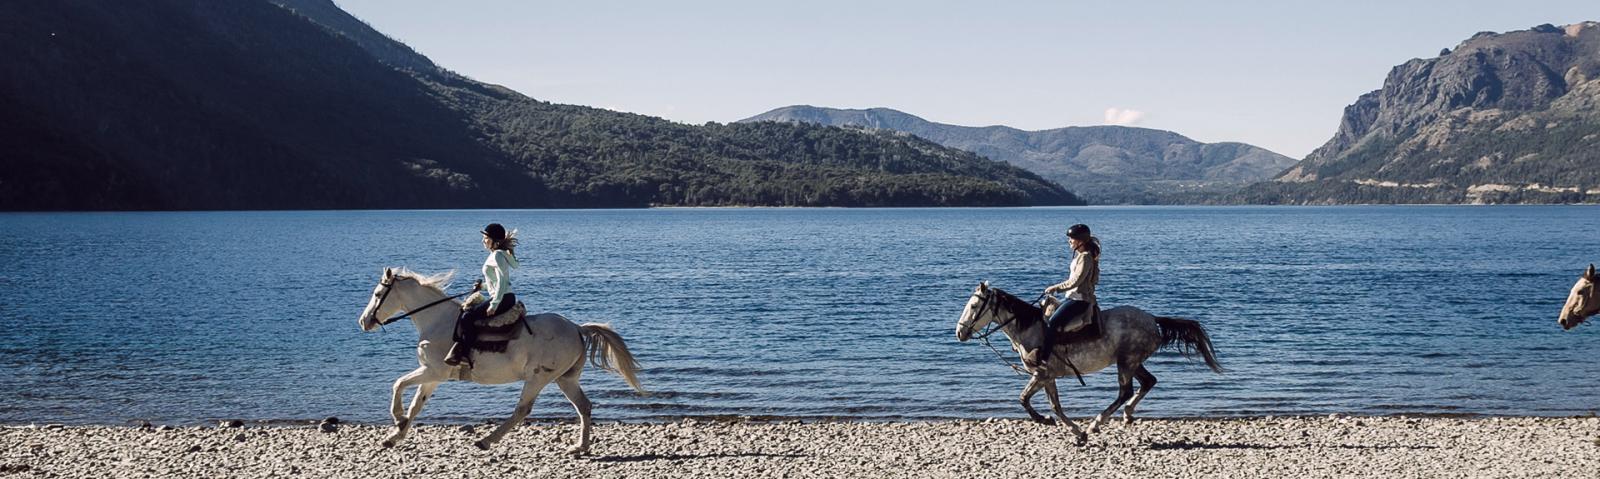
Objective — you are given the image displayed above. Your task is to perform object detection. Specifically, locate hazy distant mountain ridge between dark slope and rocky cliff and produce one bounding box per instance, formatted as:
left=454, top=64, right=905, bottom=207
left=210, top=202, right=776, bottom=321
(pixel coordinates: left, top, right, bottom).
left=741, top=106, right=1294, bottom=203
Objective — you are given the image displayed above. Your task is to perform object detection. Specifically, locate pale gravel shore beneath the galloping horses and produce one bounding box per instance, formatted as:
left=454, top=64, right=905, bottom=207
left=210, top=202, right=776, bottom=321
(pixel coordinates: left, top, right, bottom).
left=0, top=417, right=1600, bottom=479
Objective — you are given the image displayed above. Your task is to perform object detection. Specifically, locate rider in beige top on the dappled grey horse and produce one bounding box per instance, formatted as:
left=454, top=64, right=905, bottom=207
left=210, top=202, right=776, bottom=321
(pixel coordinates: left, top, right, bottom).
left=1022, top=224, right=1099, bottom=365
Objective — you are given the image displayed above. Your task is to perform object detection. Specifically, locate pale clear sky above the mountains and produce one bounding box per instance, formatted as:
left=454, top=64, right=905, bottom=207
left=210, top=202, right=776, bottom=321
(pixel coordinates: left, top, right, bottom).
left=336, top=0, right=1600, bottom=159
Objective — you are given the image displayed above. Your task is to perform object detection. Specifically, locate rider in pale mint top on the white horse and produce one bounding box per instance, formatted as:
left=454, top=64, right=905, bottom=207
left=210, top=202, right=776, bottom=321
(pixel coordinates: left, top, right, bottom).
left=445, top=223, right=520, bottom=367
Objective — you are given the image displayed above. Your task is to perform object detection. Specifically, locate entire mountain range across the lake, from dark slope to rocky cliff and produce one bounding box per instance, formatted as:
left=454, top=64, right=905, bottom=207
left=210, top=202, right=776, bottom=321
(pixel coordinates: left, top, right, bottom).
left=9, top=0, right=1600, bottom=210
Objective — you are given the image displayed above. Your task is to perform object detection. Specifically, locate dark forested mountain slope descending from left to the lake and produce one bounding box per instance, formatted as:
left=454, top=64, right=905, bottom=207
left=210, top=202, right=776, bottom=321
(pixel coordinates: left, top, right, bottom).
left=0, top=0, right=1082, bottom=210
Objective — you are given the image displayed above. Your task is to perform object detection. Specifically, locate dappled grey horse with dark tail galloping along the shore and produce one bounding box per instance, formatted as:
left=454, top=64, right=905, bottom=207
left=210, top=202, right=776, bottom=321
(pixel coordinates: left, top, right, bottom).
left=955, top=284, right=1222, bottom=445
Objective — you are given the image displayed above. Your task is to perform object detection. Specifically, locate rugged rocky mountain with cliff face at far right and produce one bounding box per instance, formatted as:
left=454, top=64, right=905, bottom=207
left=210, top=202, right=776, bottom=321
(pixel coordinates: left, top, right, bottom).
left=1242, top=22, right=1600, bottom=203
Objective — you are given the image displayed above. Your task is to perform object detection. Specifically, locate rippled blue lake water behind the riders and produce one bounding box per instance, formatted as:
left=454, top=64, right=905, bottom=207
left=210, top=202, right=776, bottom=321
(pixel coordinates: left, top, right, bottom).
left=0, top=207, right=1600, bottom=423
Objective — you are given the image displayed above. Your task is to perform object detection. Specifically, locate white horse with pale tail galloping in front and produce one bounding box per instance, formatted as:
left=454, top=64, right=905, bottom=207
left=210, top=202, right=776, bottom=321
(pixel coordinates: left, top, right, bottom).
left=358, top=269, right=645, bottom=455
